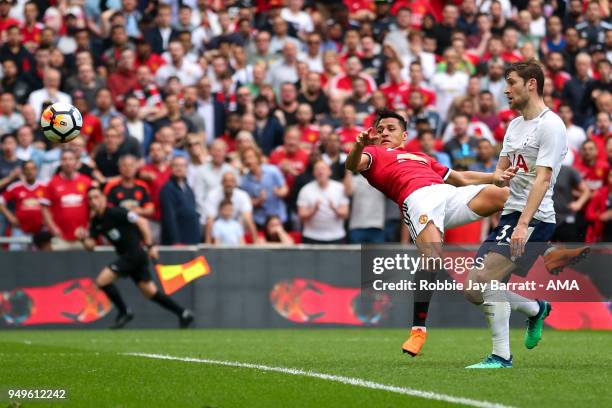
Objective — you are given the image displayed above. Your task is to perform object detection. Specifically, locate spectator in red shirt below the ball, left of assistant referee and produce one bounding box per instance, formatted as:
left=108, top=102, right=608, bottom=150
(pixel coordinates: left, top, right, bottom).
left=40, top=149, right=91, bottom=250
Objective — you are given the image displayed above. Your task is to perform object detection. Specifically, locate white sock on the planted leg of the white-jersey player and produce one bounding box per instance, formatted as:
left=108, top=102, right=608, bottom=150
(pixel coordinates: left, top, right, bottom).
left=481, top=290, right=511, bottom=360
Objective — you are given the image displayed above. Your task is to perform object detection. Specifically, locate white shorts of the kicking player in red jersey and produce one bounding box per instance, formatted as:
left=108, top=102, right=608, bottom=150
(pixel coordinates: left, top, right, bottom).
left=402, top=184, right=487, bottom=242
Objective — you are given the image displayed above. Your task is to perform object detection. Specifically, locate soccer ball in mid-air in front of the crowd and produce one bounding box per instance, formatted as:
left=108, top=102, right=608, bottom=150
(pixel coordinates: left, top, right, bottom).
left=40, top=102, right=83, bottom=143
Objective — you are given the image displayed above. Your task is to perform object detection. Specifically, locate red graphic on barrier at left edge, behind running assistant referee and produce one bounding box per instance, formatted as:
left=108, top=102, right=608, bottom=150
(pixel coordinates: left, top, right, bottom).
left=0, top=278, right=111, bottom=326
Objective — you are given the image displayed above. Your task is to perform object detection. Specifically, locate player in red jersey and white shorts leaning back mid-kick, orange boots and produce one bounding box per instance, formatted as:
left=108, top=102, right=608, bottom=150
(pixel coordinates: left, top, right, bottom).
left=345, top=111, right=580, bottom=356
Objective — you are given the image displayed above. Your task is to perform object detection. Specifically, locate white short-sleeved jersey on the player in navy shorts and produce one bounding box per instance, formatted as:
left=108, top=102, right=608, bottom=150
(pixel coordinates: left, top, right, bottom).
left=499, top=108, right=568, bottom=223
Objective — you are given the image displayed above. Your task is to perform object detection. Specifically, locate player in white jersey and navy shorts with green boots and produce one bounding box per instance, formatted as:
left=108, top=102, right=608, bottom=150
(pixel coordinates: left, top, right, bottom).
left=465, top=61, right=567, bottom=368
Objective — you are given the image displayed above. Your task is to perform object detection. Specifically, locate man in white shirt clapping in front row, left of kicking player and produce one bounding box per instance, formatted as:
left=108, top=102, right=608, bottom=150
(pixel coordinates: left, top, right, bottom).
left=297, top=160, right=349, bottom=244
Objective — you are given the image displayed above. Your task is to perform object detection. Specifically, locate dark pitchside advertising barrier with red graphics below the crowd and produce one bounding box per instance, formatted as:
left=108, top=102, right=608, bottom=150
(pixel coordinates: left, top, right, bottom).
left=0, top=245, right=612, bottom=329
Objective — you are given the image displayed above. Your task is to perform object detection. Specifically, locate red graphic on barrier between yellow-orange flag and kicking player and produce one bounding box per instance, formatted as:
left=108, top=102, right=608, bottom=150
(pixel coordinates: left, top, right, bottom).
left=270, top=279, right=391, bottom=326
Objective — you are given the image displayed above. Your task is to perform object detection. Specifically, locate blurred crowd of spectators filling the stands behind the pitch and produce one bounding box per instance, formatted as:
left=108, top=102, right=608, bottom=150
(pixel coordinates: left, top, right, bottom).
left=0, top=0, right=612, bottom=248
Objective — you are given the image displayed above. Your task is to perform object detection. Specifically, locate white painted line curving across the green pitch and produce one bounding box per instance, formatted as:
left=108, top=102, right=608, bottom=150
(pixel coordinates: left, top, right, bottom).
left=122, top=353, right=511, bottom=408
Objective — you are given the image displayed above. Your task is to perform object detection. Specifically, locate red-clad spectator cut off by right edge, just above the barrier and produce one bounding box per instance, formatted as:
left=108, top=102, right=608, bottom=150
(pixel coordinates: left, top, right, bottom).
left=585, top=172, right=612, bottom=242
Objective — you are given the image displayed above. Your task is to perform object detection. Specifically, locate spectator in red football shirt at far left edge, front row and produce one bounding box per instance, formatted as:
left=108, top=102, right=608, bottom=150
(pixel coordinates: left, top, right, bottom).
left=0, top=161, right=45, bottom=250
